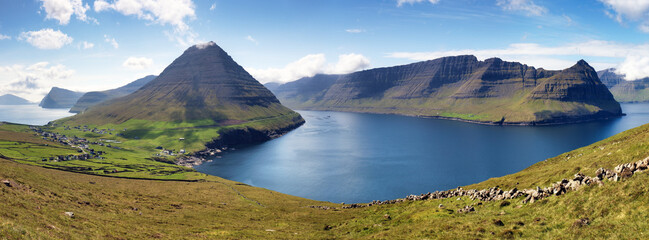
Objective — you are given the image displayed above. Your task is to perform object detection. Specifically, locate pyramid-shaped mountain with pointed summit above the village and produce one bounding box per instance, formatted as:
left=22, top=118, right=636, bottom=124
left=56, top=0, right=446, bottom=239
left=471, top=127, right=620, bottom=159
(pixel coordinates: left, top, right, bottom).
left=64, top=42, right=304, bottom=127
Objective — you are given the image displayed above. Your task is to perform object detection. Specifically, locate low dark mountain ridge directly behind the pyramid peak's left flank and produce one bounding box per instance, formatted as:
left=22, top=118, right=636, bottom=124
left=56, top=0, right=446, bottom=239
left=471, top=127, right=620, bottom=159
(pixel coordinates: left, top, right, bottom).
left=70, top=75, right=157, bottom=113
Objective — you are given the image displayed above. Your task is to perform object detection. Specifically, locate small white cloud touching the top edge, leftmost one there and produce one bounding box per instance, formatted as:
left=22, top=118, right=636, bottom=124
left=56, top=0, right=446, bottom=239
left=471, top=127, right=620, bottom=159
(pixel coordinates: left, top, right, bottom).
left=41, top=0, right=90, bottom=25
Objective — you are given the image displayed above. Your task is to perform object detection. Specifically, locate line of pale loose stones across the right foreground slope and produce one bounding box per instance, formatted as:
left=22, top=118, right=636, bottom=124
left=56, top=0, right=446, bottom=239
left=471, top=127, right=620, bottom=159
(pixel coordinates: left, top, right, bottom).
left=308, top=157, right=649, bottom=210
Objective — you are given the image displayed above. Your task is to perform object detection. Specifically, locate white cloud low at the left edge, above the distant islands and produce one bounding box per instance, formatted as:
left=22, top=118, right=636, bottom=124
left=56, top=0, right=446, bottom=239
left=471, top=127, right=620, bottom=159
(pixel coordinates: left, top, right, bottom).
left=0, top=62, right=75, bottom=102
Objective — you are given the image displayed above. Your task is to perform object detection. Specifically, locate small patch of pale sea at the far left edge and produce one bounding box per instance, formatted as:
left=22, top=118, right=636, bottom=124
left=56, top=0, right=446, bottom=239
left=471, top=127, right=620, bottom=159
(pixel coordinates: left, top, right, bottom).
left=0, top=104, right=74, bottom=125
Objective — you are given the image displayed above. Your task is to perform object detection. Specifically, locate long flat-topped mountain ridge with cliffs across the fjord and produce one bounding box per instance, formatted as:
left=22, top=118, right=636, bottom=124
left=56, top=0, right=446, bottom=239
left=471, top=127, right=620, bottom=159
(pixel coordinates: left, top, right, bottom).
left=274, top=55, right=622, bottom=125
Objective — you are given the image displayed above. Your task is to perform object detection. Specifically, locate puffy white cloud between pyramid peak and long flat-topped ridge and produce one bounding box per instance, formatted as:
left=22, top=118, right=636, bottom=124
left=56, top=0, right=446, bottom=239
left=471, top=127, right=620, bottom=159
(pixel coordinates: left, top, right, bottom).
left=246, top=53, right=370, bottom=83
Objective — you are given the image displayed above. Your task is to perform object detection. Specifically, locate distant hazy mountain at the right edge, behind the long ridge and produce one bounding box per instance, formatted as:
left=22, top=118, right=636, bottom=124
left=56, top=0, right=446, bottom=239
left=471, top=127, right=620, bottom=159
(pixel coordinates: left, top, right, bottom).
left=597, top=68, right=649, bottom=102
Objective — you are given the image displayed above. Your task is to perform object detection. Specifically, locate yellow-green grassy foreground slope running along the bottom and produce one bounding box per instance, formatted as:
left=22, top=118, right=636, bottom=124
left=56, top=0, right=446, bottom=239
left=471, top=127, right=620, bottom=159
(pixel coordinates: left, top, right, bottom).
left=0, top=120, right=649, bottom=239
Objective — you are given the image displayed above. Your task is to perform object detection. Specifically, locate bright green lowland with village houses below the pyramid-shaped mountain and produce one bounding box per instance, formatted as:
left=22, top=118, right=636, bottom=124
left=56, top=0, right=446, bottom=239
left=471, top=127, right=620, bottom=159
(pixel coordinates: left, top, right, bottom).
left=0, top=112, right=302, bottom=180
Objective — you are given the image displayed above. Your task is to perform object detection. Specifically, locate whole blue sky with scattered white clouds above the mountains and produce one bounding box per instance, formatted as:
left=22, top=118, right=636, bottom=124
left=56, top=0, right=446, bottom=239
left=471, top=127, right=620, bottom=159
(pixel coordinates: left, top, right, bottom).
left=0, top=0, right=649, bottom=102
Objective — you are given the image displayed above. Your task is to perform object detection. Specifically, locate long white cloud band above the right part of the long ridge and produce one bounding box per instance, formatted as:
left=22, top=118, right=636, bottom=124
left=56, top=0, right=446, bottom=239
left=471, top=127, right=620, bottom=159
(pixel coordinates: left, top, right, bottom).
left=387, top=40, right=649, bottom=79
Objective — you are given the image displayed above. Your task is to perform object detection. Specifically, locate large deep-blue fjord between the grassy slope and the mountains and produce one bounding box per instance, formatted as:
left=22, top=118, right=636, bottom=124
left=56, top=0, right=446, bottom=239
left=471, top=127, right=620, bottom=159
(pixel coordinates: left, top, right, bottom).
left=196, top=103, right=649, bottom=203
